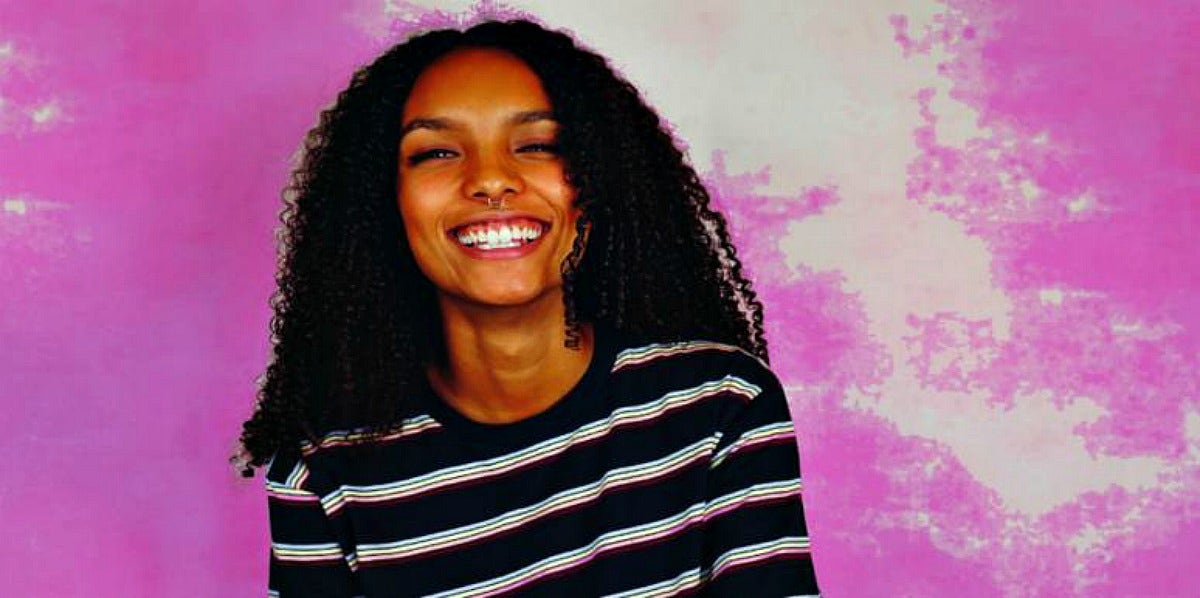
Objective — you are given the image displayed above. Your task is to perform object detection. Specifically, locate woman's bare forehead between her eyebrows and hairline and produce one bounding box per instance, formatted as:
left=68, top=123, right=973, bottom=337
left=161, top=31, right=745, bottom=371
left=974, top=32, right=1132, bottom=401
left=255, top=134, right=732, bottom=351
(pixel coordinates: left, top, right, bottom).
left=404, top=48, right=551, bottom=120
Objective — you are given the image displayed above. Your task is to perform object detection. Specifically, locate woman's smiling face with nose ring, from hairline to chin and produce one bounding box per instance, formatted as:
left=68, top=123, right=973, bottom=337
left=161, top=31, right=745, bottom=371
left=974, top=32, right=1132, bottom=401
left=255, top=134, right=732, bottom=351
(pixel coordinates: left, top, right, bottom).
left=398, top=48, right=578, bottom=306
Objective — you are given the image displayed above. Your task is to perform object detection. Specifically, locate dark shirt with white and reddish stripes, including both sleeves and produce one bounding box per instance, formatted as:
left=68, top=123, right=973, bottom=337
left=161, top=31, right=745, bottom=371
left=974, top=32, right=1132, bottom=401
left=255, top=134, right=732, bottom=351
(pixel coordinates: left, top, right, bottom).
left=266, top=328, right=817, bottom=597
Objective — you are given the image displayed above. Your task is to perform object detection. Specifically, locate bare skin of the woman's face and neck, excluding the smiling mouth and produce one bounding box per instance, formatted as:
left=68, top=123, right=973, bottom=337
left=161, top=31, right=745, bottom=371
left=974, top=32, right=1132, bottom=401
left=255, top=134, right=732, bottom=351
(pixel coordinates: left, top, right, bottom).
left=397, top=48, right=593, bottom=424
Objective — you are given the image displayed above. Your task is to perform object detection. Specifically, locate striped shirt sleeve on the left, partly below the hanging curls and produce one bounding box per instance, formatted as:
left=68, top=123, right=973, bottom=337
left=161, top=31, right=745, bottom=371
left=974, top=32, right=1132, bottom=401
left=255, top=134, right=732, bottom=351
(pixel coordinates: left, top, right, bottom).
left=266, top=456, right=361, bottom=598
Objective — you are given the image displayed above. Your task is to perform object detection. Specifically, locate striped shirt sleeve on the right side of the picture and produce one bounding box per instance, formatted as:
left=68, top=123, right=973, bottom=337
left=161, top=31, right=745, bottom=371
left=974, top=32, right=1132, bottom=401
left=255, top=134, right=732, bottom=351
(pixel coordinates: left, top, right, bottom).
left=702, top=364, right=818, bottom=597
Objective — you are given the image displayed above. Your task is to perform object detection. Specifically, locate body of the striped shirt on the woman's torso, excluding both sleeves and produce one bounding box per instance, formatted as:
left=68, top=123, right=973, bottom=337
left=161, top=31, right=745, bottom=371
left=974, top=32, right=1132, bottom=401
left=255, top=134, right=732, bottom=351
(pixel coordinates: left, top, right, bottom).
left=270, top=324, right=816, bottom=596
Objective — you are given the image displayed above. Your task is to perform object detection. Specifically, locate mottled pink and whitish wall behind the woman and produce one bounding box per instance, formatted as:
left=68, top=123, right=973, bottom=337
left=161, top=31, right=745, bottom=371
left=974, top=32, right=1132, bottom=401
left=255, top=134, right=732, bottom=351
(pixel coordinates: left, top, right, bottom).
left=0, top=0, right=1200, bottom=598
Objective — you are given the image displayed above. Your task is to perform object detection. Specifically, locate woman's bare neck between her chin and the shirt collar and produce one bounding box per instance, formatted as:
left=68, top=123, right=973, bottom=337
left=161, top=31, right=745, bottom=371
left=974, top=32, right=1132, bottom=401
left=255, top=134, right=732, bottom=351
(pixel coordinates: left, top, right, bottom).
left=430, top=293, right=594, bottom=424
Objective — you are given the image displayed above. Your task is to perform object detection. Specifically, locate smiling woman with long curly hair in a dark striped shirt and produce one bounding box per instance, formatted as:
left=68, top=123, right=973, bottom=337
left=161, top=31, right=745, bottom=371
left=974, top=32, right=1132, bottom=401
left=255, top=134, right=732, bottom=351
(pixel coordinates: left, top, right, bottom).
left=242, top=22, right=817, bottom=596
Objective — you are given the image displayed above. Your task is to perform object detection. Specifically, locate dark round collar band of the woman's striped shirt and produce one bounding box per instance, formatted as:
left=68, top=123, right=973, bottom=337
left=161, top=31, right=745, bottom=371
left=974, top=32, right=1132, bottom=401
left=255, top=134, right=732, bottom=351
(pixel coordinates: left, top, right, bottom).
left=421, top=323, right=617, bottom=445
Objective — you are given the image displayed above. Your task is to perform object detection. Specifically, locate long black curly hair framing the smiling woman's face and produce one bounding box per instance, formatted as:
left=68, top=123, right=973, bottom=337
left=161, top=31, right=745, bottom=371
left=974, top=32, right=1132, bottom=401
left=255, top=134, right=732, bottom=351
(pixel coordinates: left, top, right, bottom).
left=234, top=20, right=768, bottom=476
